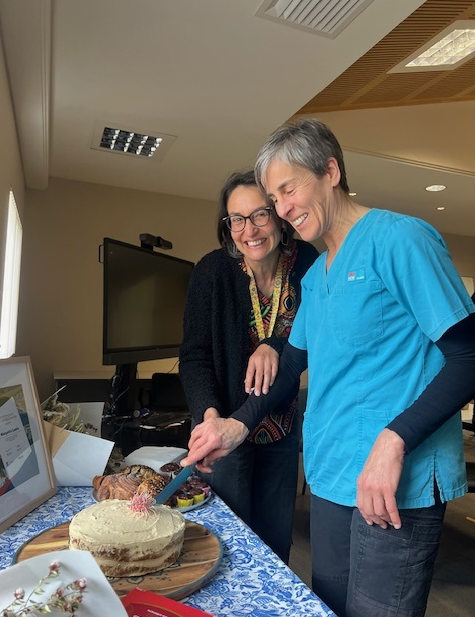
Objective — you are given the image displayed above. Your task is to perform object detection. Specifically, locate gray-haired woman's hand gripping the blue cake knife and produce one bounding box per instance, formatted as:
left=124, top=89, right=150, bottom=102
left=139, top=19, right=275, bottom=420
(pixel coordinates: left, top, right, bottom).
left=180, top=418, right=249, bottom=473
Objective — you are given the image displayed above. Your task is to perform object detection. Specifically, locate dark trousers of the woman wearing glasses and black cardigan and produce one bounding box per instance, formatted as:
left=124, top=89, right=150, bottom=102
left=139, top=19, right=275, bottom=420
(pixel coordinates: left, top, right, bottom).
left=197, top=414, right=301, bottom=563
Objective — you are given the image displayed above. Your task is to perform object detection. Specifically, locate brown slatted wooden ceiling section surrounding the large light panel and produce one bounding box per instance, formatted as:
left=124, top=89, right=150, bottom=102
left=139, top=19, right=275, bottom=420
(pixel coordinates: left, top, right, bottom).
left=296, top=0, right=475, bottom=115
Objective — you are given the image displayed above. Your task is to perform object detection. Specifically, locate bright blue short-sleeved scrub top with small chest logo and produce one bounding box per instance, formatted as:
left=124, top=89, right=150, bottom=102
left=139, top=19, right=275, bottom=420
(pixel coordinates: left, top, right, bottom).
left=289, top=209, right=475, bottom=508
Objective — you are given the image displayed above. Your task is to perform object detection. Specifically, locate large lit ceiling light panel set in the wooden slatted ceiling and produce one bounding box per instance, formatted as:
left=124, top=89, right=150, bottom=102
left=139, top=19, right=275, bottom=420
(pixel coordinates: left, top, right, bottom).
left=389, top=20, right=475, bottom=73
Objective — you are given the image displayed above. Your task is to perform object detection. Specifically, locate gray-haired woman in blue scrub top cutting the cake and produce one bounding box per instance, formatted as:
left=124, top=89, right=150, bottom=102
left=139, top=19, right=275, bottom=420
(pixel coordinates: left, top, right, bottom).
left=182, top=119, right=475, bottom=617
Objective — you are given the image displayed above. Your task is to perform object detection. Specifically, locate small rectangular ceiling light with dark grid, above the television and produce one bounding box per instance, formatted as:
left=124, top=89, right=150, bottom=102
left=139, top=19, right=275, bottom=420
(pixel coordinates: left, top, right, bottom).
left=91, top=122, right=176, bottom=159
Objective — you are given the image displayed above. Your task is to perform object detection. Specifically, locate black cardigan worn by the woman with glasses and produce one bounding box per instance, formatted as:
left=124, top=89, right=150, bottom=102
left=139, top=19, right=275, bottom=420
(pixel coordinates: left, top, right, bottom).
left=179, top=240, right=318, bottom=423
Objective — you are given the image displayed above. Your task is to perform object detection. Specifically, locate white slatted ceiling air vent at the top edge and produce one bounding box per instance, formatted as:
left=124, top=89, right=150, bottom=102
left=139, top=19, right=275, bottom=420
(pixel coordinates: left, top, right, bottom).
left=256, top=0, right=373, bottom=38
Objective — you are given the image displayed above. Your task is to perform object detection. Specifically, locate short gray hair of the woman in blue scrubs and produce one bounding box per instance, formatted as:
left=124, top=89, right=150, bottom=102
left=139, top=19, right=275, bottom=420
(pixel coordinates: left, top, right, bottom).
left=254, top=118, right=350, bottom=194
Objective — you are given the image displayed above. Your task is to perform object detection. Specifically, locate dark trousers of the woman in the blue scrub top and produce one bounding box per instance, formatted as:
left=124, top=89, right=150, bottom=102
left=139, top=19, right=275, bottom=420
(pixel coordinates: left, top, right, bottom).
left=310, top=488, right=446, bottom=617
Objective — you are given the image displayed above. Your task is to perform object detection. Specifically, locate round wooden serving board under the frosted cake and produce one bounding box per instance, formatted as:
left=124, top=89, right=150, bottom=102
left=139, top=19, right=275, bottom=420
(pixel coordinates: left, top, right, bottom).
left=13, top=521, right=223, bottom=600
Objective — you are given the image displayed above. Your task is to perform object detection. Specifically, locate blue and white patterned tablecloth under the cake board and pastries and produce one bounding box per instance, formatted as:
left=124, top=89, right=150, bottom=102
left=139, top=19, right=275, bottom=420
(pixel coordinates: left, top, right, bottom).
left=0, top=487, right=334, bottom=617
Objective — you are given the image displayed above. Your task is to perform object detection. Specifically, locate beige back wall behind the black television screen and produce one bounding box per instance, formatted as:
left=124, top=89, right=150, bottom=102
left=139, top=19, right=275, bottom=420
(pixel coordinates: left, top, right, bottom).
left=17, top=178, right=218, bottom=400
